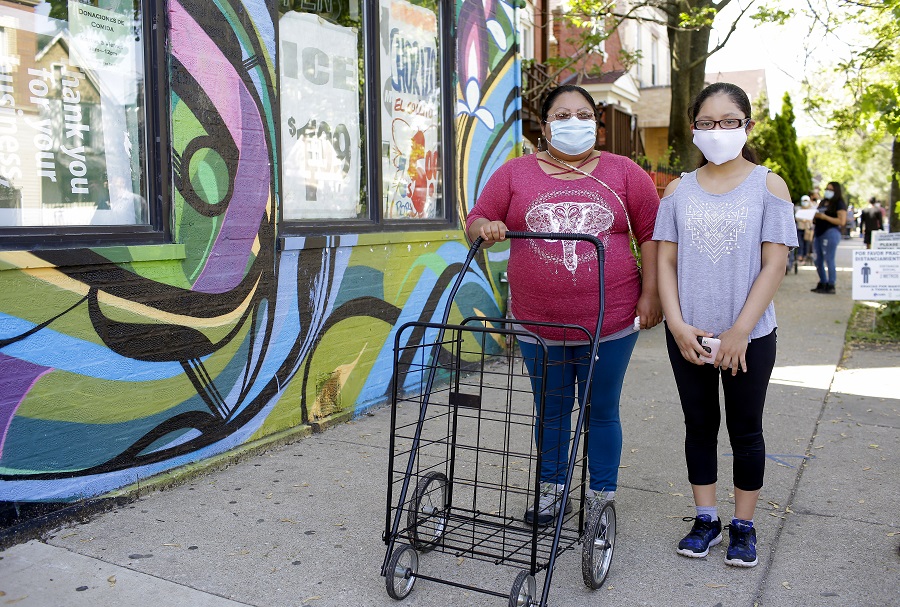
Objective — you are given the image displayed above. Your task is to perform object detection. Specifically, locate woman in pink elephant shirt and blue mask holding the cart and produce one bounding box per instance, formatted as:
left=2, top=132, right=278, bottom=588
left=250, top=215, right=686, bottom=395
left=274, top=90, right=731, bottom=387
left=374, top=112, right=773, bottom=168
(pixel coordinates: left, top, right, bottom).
left=466, top=85, right=662, bottom=525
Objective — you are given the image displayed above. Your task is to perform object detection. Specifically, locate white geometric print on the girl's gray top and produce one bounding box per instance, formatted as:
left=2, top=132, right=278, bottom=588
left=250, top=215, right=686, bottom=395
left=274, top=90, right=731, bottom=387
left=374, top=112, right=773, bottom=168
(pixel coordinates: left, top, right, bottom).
left=684, top=196, right=747, bottom=263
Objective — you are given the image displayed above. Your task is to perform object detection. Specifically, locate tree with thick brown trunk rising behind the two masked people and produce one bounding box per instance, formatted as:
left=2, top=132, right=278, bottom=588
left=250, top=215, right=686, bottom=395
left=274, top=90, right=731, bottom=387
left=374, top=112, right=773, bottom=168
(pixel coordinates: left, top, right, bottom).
left=532, top=0, right=791, bottom=168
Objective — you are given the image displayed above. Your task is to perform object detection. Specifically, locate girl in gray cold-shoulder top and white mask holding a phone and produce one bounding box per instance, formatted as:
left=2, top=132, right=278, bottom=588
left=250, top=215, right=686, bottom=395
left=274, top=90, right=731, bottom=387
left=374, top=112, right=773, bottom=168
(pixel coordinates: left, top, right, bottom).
left=653, top=83, right=797, bottom=567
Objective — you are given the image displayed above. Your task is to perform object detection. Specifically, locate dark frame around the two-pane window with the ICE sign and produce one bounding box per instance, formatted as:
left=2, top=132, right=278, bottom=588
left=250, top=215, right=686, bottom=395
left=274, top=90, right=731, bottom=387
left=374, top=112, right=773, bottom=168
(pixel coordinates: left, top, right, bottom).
left=275, top=0, right=457, bottom=240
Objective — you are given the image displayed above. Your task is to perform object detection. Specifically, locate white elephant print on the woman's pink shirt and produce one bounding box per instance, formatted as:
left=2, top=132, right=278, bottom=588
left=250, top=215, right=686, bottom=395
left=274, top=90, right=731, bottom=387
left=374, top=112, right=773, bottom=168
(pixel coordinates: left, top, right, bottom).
left=525, top=190, right=615, bottom=274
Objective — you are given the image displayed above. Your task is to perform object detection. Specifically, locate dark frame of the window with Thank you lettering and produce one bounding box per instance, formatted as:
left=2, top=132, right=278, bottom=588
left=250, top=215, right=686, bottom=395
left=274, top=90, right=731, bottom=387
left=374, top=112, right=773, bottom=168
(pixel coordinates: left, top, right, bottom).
left=0, top=0, right=174, bottom=250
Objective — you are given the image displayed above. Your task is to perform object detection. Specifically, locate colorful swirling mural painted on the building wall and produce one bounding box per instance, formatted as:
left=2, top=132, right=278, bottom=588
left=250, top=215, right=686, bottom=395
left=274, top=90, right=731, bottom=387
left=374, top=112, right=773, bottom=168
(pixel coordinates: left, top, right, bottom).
left=0, top=0, right=518, bottom=502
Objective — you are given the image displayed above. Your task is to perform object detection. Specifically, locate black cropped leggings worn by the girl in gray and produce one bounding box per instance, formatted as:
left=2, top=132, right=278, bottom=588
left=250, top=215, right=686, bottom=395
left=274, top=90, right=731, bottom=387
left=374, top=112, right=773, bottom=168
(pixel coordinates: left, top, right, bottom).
left=666, top=327, right=777, bottom=491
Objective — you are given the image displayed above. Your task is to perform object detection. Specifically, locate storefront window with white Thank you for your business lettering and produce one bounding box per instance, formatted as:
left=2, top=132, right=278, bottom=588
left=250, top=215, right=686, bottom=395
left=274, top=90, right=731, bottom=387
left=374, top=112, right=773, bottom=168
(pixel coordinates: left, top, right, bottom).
left=0, top=0, right=150, bottom=227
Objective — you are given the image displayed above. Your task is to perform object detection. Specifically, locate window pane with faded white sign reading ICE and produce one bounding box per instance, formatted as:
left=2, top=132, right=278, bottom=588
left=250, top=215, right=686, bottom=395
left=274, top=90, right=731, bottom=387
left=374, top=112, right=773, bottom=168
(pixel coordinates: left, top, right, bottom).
left=278, top=0, right=368, bottom=220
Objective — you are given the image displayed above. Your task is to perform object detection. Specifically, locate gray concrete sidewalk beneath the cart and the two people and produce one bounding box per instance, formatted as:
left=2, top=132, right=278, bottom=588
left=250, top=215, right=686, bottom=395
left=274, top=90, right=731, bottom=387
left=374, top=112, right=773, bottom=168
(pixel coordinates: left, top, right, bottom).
left=0, top=241, right=900, bottom=607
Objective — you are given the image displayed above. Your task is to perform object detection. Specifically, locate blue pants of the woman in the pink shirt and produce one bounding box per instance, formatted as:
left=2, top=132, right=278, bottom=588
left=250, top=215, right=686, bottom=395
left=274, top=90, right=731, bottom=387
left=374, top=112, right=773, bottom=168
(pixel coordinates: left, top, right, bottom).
left=519, top=333, right=638, bottom=491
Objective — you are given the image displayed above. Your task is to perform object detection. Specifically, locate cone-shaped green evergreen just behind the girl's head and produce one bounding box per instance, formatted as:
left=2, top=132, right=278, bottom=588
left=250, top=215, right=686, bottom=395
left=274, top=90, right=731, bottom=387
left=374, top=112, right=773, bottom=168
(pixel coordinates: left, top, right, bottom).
left=750, top=93, right=812, bottom=201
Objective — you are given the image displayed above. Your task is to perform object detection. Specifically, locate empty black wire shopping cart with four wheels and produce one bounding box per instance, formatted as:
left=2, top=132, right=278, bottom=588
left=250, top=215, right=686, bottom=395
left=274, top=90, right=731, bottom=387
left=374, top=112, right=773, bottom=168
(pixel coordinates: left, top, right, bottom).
left=381, top=232, right=616, bottom=607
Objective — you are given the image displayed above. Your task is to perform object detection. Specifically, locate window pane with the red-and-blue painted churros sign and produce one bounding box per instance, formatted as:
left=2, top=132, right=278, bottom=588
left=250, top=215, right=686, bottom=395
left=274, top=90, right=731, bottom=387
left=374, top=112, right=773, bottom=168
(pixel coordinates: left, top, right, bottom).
left=380, top=0, right=444, bottom=219
